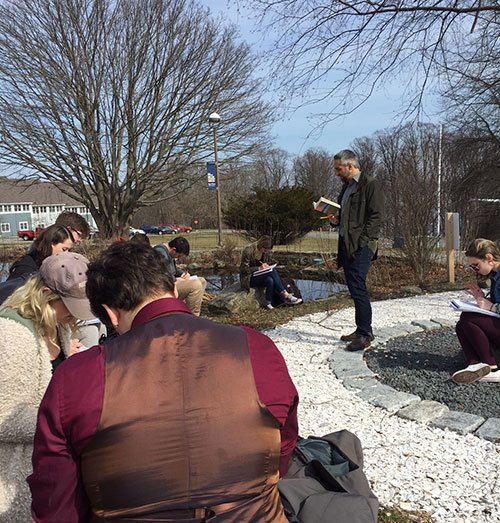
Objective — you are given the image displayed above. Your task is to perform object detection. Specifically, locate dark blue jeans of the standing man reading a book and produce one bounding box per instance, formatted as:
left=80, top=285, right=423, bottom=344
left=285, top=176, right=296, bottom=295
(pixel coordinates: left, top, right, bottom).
left=339, top=237, right=373, bottom=336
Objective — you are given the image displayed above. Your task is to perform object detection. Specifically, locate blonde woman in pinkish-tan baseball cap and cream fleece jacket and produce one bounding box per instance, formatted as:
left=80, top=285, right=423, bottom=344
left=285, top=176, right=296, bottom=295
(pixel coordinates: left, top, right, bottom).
left=0, top=252, right=93, bottom=522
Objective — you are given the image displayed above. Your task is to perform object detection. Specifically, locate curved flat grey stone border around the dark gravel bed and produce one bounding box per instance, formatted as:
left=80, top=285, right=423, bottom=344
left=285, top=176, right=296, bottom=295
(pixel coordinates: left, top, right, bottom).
left=328, top=319, right=500, bottom=443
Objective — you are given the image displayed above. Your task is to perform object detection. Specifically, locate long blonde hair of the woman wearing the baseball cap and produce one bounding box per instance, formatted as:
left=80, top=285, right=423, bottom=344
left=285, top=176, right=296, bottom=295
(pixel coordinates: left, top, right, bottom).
left=2, top=274, right=76, bottom=348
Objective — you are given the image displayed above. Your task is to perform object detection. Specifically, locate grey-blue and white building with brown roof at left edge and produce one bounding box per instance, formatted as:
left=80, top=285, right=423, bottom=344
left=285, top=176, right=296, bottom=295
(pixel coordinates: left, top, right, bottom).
left=0, top=177, right=96, bottom=237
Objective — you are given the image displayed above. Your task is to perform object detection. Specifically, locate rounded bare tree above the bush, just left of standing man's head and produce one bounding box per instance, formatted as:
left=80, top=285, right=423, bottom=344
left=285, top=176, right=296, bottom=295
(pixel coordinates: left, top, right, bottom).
left=293, top=149, right=341, bottom=197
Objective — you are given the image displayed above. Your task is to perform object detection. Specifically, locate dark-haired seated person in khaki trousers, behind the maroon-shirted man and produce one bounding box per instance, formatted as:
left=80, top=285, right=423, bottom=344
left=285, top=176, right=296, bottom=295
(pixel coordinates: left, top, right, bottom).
left=154, top=236, right=207, bottom=316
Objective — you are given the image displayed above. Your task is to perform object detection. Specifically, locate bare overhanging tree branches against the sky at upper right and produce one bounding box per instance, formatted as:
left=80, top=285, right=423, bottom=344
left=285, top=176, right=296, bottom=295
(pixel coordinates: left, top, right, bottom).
left=240, top=0, right=500, bottom=122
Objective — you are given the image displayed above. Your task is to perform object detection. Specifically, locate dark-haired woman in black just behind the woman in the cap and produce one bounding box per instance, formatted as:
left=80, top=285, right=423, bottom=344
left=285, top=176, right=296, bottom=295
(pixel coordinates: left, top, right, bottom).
left=0, top=225, right=74, bottom=304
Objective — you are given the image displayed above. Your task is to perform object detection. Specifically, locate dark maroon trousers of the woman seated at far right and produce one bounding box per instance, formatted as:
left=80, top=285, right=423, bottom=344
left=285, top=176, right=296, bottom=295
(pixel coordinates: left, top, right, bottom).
left=455, top=312, right=500, bottom=365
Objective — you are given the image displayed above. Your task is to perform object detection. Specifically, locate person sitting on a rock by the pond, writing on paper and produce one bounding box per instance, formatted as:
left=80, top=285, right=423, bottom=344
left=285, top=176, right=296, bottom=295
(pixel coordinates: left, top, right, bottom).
left=240, top=236, right=302, bottom=310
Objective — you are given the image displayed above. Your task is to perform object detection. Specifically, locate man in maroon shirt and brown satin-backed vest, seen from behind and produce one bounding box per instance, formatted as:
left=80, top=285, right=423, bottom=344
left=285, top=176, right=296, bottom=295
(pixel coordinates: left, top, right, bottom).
left=28, top=242, right=298, bottom=523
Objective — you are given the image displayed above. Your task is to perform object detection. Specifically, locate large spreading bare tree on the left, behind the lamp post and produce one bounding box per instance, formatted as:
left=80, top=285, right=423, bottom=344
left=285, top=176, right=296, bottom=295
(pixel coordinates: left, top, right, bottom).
left=0, top=0, right=272, bottom=236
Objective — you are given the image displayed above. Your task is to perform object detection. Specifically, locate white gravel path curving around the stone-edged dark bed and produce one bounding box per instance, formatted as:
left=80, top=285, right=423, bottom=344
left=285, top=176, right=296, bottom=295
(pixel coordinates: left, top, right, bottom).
left=267, top=292, right=500, bottom=523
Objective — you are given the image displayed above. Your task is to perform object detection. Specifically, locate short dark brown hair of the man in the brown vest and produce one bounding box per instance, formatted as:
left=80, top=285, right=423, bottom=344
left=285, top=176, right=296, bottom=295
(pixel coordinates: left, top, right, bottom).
left=86, top=241, right=175, bottom=325
